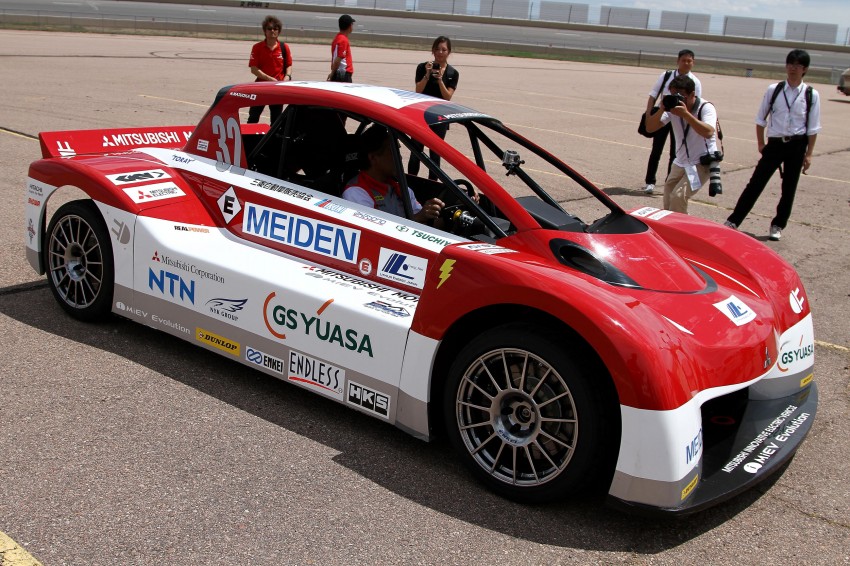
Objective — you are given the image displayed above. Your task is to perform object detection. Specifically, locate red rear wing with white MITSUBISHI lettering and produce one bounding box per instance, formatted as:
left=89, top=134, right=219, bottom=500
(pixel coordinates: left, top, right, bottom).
left=38, top=124, right=269, bottom=158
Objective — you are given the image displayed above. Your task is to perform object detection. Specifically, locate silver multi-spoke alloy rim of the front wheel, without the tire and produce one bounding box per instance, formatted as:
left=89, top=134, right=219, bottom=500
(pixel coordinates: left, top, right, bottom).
left=455, top=348, right=579, bottom=487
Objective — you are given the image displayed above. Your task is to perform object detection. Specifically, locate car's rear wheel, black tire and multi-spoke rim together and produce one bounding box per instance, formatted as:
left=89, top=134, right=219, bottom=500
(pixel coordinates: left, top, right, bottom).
left=43, top=200, right=115, bottom=322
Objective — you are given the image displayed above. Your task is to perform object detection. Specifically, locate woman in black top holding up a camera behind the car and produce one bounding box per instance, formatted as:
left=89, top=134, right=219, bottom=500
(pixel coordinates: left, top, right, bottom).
left=407, top=35, right=460, bottom=179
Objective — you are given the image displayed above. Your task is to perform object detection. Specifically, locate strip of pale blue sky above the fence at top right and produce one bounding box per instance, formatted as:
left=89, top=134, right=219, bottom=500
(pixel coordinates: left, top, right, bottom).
left=596, top=0, right=850, bottom=32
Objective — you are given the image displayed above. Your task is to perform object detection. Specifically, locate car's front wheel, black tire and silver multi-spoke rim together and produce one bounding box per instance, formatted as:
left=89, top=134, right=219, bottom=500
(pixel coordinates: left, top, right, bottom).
left=443, top=323, right=620, bottom=503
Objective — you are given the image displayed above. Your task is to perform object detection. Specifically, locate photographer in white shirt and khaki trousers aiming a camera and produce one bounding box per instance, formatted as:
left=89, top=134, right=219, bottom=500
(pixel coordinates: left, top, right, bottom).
left=646, top=75, right=723, bottom=214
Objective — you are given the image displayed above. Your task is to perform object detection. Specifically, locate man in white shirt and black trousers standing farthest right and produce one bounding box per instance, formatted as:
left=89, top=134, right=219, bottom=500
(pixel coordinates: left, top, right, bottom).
left=724, top=49, right=820, bottom=240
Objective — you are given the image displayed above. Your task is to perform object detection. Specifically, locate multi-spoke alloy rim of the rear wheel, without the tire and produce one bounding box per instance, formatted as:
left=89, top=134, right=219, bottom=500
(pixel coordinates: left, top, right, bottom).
left=47, top=214, right=104, bottom=309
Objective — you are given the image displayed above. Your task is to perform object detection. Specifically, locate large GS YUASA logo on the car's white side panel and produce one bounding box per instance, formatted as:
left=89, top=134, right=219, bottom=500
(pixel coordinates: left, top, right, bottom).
left=263, top=291, right=374, bottom=358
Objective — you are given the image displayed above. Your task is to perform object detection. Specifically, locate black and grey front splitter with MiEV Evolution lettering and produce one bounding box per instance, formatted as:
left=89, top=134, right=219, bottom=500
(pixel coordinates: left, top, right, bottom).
left=609, top=381, right=818, bottom=515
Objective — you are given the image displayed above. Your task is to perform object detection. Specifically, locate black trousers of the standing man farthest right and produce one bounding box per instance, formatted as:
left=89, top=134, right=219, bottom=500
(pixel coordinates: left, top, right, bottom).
left=728, top=136, right=809, bottom=228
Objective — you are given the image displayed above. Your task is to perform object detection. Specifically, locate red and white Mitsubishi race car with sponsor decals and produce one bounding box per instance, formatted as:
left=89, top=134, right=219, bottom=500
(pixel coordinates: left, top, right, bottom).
left=25, top=82, right=817, bottom=513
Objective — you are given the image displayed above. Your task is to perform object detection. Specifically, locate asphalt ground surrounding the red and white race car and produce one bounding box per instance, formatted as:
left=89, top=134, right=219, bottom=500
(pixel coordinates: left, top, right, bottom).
left=0, top=31, right=850, bottom=565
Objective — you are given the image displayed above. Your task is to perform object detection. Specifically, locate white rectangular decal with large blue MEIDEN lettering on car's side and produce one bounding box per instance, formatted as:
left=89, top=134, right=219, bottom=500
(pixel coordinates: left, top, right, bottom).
left=242, top=202, right=360, bottom=264
